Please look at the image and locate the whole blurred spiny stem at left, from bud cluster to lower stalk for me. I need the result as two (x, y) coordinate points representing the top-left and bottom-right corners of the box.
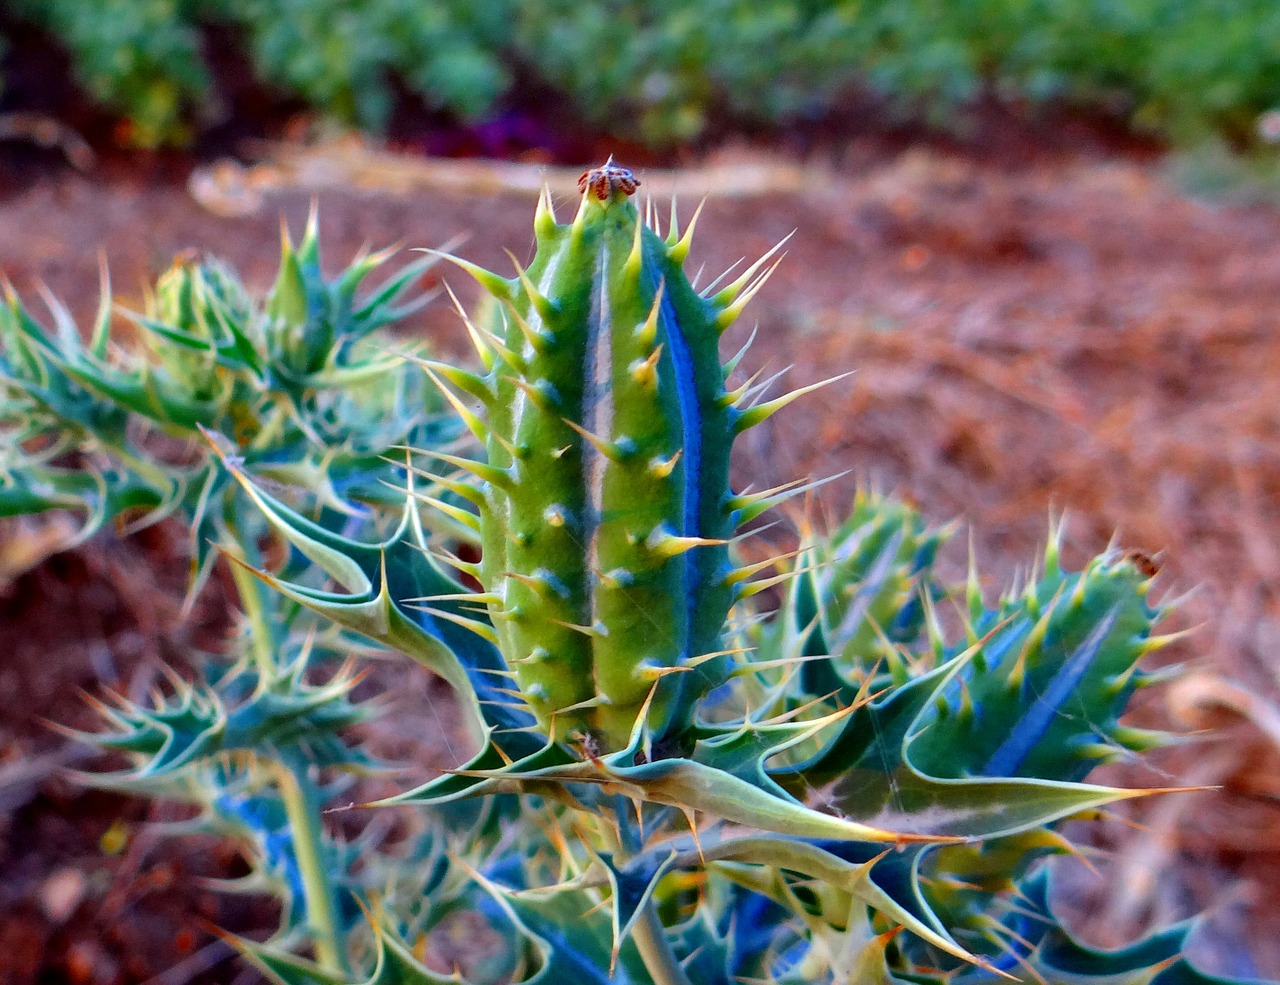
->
(0, 210), (471, 967)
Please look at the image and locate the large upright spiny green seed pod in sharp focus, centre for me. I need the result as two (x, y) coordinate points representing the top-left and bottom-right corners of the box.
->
(428, 159), (804, 750)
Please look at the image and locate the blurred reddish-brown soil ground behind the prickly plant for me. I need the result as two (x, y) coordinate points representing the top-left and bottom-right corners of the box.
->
(0, 126), (1280, 985)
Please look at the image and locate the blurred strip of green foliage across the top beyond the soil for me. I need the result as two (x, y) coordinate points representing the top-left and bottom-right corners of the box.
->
(0, 0), (1280, 146)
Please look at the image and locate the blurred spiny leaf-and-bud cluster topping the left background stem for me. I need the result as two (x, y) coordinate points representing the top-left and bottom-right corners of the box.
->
(0, 211), (458, 587)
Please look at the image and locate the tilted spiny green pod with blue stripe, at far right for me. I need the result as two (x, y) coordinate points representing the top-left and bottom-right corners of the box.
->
(911, 544), (1179, 782)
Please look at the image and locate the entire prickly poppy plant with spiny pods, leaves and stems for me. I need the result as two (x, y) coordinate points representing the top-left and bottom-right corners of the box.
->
(0, 160), (1269, 985)
